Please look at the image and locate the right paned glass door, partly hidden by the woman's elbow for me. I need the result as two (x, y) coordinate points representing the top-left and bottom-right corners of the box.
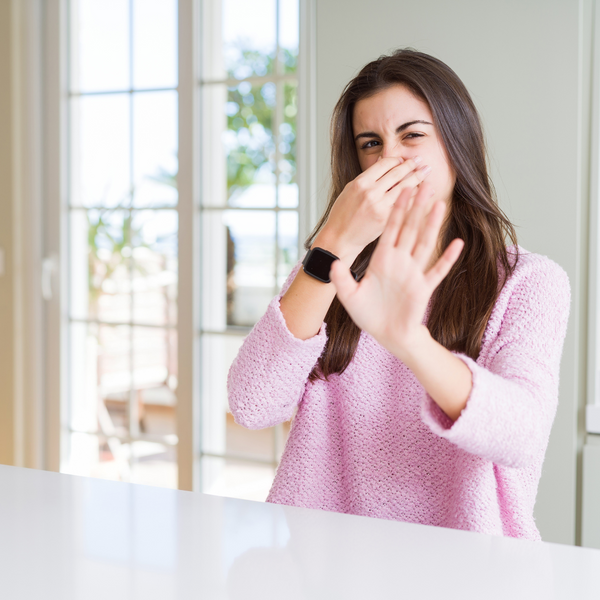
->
(199, 0), (299, 499)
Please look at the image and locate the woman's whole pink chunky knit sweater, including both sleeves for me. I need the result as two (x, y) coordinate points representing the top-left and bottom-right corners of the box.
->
(228, 248), (570, 540)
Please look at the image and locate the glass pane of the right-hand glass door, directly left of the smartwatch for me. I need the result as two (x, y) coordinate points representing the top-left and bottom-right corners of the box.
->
(224, 210), (276, 326)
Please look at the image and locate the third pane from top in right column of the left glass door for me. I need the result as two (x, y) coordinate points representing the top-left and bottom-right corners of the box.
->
(131, 210), (178, 325)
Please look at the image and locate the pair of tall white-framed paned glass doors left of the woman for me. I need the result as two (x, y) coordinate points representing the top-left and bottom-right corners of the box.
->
(55, 0), (307, 500)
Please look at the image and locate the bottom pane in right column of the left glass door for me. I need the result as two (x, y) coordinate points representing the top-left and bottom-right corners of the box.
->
(131, 441), (177, 489)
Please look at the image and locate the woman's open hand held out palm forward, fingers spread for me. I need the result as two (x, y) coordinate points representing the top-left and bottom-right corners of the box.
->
(331, 183), (464, 360)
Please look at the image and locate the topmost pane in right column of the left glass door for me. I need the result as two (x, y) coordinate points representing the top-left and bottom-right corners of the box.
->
(133, 0), (177, 89)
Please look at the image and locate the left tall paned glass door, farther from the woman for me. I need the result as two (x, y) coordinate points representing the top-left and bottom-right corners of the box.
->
(63, 0), (178, 487)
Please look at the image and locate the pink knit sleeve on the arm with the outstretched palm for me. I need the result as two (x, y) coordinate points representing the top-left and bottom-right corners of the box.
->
(422, 256), (570, 468)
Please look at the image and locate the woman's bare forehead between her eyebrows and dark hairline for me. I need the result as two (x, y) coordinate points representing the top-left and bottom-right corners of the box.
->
(352, 85), (433, 135)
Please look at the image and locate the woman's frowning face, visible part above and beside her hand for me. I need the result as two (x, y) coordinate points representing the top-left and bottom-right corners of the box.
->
(352, 85), (456, 203)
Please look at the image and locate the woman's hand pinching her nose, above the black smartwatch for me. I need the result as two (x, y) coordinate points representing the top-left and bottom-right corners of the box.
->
(313, 156), (431, 264)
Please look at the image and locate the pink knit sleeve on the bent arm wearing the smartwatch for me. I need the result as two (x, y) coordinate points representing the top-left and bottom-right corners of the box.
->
(227, 263), (327, 429)
